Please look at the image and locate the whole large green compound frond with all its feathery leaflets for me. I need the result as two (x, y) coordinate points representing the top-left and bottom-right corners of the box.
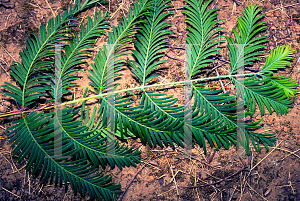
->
(3, 0), (298, 200)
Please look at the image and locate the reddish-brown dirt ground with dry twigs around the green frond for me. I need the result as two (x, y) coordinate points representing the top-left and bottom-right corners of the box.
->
(0, 0), (300, 201)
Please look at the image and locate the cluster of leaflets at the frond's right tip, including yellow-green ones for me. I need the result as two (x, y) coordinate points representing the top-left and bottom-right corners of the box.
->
(227, 4), (296, 118)
